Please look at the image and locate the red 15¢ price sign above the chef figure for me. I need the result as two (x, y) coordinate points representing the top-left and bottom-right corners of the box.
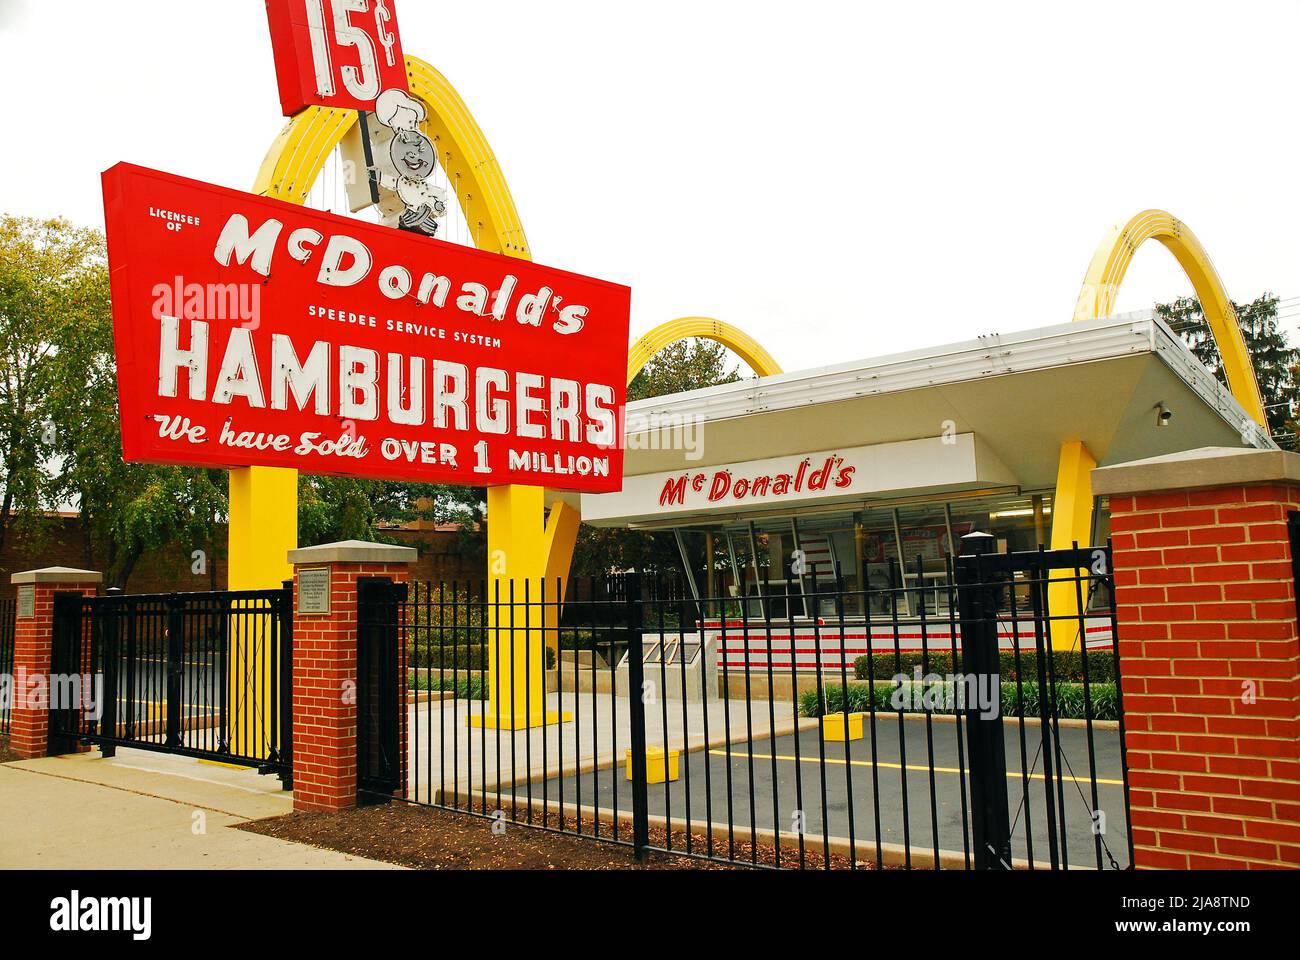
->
(267, 0), (408, 117)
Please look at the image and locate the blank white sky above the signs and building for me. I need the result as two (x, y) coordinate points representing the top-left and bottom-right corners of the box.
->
(0, 0), (1300, 369)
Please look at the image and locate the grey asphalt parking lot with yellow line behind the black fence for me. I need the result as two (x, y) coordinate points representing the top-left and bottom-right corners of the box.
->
(534, 714), (1128, 869)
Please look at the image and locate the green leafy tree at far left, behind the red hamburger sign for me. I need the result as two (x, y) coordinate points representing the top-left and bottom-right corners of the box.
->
(0, 216), (226, 587)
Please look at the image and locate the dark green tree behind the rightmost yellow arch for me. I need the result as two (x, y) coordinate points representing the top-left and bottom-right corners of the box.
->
(1156, 293), (1300, 450)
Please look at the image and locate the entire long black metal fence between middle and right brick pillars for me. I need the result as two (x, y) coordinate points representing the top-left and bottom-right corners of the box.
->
(359, 548), (1132, 869)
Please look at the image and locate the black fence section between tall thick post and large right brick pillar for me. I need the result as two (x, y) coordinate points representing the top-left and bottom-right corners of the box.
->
(956, 539), (1132, 870)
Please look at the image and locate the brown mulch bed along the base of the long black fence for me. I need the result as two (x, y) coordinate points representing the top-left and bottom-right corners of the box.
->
(238, 803), (870, 870)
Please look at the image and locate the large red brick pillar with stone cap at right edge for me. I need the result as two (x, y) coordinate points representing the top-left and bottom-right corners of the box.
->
(1093, 447), (1300, 869)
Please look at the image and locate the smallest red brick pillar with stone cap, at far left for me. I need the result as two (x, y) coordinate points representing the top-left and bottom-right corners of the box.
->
(9, 567), (104, 760)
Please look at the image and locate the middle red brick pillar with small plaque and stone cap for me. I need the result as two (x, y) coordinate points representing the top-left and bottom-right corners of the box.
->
(289, 540), (419, 812)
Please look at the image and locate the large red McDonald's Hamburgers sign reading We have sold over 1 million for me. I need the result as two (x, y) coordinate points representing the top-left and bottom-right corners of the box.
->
(104, 164), (631, 493)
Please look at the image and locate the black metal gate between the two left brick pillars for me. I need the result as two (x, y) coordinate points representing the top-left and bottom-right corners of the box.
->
(49, 585), (293, 783)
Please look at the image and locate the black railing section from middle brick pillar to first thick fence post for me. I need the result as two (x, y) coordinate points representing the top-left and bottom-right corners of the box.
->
(392, 578), (642, 844)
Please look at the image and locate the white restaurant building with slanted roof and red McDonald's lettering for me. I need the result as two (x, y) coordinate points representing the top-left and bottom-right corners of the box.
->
(581, 312), (1274, 670)
